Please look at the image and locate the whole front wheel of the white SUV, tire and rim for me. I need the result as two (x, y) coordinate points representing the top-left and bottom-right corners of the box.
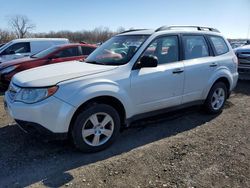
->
(71, 104), (121, 153)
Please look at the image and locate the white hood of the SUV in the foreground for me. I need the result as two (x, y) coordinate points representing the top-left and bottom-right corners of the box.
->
(12, 61), (117, 87)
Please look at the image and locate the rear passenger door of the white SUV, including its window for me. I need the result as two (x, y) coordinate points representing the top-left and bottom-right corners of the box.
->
(182, 34), (218, 103)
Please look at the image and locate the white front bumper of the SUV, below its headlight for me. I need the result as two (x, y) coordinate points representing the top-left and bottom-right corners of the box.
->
(4, 92), (76, 133)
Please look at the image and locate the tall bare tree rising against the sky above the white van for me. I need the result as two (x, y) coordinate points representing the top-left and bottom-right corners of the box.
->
(9, 15), (36, 38)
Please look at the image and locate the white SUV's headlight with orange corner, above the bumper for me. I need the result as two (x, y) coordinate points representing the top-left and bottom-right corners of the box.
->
(15, 86), (58, 104)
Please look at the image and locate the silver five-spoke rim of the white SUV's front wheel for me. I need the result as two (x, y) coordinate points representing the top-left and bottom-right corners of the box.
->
(82, 112), (114, 146)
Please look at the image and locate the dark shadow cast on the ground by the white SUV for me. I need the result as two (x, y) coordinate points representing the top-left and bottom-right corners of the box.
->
(0, 107), (219, 187)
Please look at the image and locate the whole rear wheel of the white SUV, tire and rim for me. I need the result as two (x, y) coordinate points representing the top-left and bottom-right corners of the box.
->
(204, 82), (228, 114)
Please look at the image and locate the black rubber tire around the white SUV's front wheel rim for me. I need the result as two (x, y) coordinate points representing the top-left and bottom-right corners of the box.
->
(71, 104), (121, 153)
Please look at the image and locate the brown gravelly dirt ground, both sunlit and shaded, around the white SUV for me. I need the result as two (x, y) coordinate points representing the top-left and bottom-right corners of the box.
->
(0, 81), (250, 188)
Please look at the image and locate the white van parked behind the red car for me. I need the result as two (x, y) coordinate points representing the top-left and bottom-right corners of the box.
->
(0, 38), (69, 63)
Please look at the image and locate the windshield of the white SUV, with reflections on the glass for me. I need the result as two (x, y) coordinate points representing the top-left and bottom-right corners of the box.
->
(86, 35), (148, 65)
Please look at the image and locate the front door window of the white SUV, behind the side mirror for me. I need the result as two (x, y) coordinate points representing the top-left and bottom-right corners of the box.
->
(142, 36), (179, 64)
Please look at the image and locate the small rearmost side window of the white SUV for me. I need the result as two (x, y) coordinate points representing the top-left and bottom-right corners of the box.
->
(209, 36), (229, 55)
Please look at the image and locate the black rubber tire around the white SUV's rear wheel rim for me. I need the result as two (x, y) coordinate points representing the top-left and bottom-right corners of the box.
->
(204, 82), (228, 114)
